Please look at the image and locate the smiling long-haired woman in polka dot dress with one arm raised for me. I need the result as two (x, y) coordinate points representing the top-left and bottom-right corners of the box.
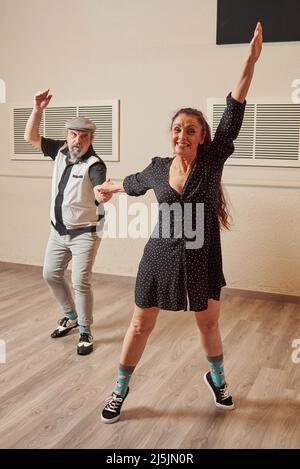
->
(99, 23), (262, 423)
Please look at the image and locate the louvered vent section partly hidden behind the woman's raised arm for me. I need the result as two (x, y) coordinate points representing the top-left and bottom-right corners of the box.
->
(212, 104), (255, 159)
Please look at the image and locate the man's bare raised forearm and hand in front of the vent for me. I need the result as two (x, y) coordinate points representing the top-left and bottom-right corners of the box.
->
(24, 90), (52, 151)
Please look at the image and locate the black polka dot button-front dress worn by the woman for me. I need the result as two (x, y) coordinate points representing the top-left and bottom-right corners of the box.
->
(124, 94), (246, 311)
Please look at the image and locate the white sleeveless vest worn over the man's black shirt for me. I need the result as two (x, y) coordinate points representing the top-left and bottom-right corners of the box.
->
(50, 144), (101, 230)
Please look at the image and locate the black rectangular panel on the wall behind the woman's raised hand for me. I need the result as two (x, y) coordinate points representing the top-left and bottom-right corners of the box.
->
(217, 0), (300, 44)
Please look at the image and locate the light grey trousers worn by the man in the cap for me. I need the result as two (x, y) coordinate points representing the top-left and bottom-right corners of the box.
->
(43, 227), (101, 326)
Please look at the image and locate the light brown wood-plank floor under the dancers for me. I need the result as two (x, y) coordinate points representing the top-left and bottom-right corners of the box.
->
(0, 264), (300, 449)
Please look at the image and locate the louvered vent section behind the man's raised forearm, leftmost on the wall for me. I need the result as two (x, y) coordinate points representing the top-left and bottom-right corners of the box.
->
(13, 108), (44, 155)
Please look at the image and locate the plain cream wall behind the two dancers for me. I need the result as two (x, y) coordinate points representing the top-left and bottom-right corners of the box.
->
(0, 0), (300, 295)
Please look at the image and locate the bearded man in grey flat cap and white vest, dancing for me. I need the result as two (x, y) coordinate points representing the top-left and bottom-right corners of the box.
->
(24, 90), (106, 355)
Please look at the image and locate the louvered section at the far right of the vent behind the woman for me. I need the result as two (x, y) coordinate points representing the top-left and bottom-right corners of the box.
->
(255, 104), (300, 161)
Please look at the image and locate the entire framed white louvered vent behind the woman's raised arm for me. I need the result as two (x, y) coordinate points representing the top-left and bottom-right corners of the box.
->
(208, 98), (300, 167)
